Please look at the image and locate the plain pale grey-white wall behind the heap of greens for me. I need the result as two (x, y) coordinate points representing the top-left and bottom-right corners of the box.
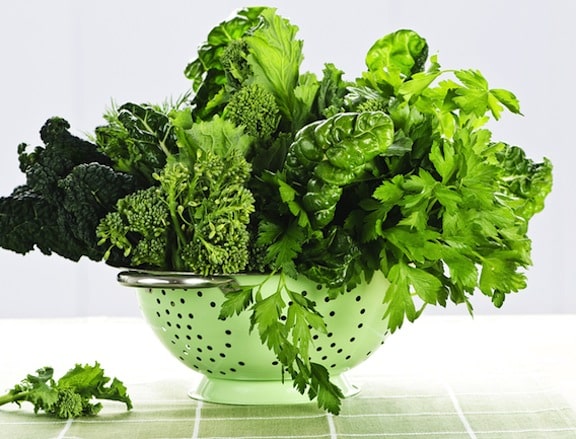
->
(0, 0), (576, 317)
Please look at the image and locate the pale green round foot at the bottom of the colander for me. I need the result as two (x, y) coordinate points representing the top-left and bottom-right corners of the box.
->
(188, 375), (360, 405)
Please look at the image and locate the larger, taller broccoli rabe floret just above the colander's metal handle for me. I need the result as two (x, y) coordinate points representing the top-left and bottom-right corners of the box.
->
(158, 149), (254, 275)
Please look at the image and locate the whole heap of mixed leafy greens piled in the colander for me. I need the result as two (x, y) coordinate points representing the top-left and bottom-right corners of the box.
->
(0, 7), (552, 413)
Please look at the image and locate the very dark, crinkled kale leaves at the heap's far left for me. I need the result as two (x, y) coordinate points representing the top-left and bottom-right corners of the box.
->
(0, 118), (135, 262)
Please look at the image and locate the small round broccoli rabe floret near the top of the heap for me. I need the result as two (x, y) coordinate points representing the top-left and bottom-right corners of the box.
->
(224, 84), (280, 140)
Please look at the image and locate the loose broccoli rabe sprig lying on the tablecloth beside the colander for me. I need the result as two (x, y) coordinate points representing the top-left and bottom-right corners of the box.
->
(0, 362), (132, 419)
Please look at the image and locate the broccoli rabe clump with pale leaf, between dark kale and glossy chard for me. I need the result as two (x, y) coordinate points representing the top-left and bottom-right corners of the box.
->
(97, 119), (254, 275)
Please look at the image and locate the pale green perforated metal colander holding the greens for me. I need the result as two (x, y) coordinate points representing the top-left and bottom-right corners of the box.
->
(118, 271), (388, 404)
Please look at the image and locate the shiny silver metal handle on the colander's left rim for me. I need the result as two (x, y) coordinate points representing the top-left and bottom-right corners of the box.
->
(117, 270), (240, 293)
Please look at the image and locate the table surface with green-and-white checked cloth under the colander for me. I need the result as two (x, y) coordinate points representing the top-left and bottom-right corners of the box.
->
(0, 315), (576, 439)
